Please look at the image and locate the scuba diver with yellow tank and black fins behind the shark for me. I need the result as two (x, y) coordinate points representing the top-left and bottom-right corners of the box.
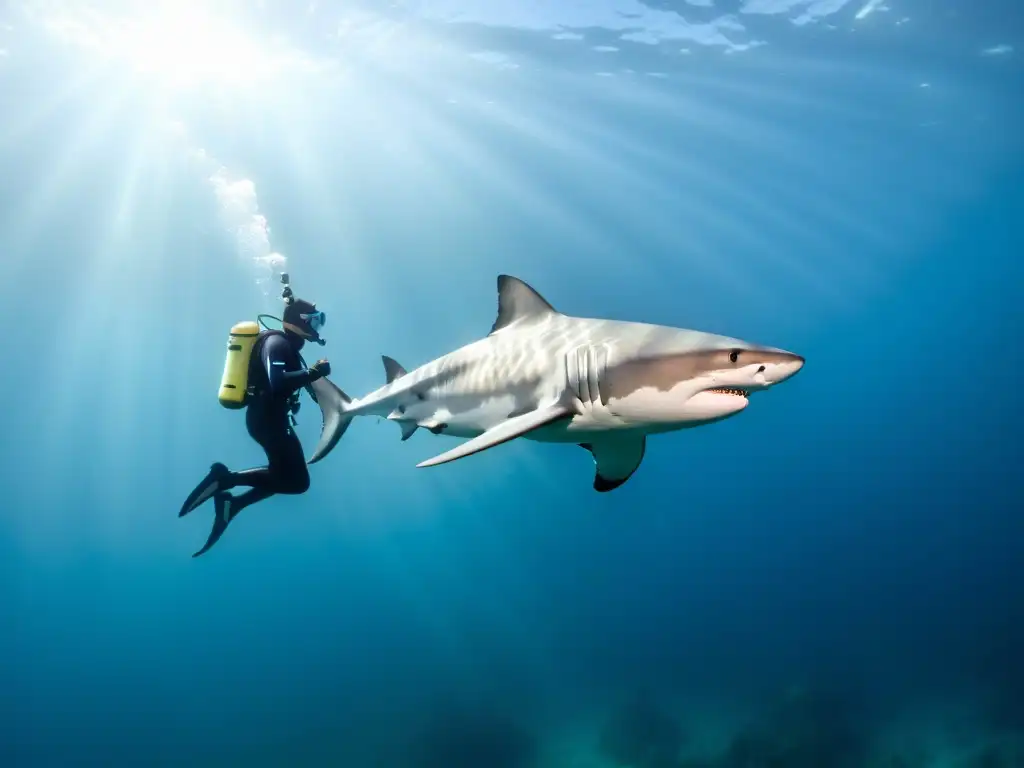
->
(178, 273), (331, 557)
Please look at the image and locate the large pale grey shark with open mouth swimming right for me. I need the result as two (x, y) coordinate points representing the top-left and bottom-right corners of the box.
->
(308, 274), (804, 493)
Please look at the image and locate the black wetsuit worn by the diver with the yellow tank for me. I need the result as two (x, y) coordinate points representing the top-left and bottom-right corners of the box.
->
(225, 333), (316, 514)
